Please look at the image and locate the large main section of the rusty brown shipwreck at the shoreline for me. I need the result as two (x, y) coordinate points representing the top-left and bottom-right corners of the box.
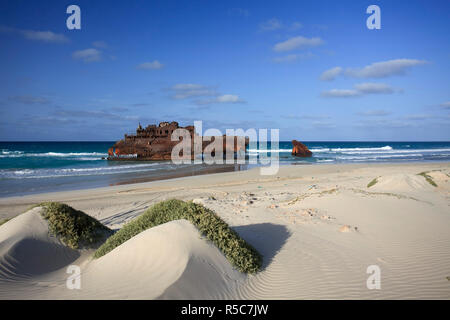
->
(107, 121), (249, 161)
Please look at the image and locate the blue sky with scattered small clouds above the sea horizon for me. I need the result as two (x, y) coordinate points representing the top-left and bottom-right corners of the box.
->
(0, 0), (450, 141)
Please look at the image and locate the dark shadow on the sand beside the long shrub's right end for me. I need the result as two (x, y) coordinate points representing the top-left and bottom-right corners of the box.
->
(232, 223), (291, 270)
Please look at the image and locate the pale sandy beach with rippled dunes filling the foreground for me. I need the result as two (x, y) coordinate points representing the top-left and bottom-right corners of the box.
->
(0, 163), (450, 299)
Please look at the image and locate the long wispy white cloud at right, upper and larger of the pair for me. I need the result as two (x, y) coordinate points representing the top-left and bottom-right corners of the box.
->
(346, 59), (427, 78)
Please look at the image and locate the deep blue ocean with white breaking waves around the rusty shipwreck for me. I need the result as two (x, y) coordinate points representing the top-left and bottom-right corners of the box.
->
(0, 141), (450, 197)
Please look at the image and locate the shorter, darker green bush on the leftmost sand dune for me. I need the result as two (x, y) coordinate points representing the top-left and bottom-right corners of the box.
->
(36, 202), (112, 249)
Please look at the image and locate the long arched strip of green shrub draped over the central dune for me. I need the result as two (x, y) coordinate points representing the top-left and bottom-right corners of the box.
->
(94, 199), (262, 273)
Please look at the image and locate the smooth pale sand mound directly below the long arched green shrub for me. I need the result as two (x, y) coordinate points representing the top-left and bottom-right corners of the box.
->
(82, 220), (242, 299)
